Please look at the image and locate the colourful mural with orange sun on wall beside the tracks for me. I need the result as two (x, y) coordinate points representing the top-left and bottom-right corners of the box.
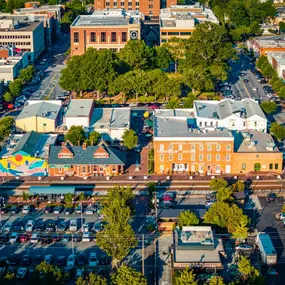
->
(0, 151), (47, 176)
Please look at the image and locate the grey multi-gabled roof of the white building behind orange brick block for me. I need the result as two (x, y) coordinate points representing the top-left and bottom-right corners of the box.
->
(194, 99), (266, 120)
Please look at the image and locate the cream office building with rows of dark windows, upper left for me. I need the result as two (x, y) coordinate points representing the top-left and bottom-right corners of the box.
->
(0, 14), (45, 62)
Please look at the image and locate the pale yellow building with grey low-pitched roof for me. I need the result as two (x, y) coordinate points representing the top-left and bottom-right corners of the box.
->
(16, 100), (61, 133)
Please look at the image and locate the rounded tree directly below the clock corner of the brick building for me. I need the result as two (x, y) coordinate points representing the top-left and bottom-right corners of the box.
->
(118, 40), (154, 70)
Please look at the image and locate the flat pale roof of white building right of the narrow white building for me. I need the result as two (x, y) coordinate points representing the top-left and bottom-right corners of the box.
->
(90, 108), (131, 130)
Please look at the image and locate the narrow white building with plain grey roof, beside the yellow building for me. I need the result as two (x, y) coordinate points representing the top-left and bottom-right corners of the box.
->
(63, 99), (94, 130)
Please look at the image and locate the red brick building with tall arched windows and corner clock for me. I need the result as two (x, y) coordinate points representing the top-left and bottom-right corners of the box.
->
(70, 9), (143, 55)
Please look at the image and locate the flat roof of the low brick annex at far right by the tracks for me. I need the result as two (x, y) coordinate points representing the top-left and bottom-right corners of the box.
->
(233, 130), (280, 153)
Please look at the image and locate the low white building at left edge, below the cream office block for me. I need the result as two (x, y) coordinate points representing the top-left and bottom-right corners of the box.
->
(0, 53), (29, 83)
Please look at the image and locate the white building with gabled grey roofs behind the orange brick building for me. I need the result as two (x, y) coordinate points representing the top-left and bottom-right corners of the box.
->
(194, 99), (267, 132)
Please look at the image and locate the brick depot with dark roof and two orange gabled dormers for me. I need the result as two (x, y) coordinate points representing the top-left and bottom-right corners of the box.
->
(48, 141), (126, 177)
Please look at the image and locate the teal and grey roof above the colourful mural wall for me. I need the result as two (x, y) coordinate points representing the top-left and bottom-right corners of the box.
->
(0, 131), (57, 158)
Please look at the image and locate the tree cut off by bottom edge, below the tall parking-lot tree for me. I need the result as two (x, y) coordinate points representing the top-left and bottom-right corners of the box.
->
(111, 264), (147, 285)
